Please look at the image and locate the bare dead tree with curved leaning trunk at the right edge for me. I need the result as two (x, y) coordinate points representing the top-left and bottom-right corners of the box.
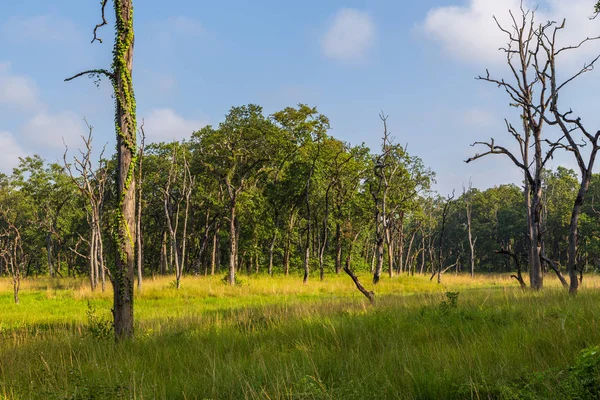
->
(535, 20), (600, 294)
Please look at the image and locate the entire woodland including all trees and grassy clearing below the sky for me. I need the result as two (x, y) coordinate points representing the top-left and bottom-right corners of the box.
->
(0, 0), (600, 399)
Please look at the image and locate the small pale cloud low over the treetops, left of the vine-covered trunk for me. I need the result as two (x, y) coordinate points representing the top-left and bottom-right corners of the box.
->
(21, 111), (86, 150)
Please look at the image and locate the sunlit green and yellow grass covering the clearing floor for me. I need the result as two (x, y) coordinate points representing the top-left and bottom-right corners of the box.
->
(0, 274), (600, 400)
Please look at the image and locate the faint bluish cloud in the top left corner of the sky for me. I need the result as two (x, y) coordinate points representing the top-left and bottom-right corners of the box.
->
(0, 15), (78, 42)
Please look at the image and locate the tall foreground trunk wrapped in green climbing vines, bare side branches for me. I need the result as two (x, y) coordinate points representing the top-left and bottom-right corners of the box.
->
(65, 0), (137, 341)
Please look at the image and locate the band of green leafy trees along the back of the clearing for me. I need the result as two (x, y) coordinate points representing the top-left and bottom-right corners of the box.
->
(0, 101), (600, 298)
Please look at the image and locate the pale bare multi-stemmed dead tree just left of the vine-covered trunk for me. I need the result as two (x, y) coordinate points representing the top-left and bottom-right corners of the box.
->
(63, 121), (107, 292)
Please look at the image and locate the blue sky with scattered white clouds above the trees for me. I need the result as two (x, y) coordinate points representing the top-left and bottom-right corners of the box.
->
(0, 0), (600, 194)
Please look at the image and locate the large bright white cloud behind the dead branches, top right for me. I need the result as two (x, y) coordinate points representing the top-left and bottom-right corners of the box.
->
(420, 0), (599, 67)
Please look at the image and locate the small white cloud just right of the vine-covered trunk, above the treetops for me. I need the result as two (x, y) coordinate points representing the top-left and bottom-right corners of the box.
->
(139, 108), (206, 143)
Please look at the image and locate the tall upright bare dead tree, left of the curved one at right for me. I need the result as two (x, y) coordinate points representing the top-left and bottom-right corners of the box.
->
(466, 7), (564, 290)
